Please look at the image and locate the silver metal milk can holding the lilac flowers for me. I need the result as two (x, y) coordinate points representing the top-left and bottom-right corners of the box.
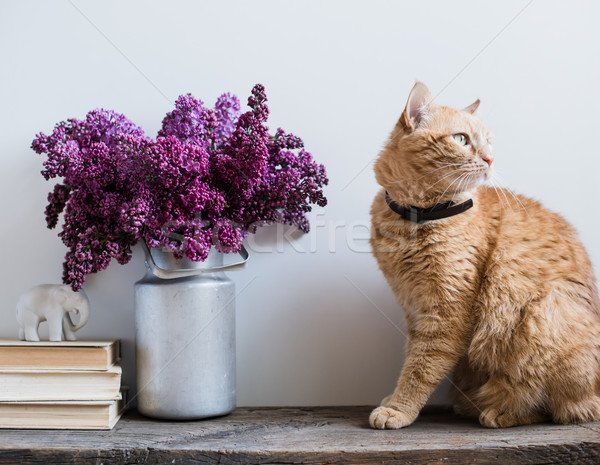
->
(135, 247), (248, 420)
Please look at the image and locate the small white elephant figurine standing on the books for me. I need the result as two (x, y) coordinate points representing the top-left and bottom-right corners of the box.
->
(17, 284), (90, 341)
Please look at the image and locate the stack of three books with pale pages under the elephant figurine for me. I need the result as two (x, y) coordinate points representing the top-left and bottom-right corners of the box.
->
(0, 340), (125, 429)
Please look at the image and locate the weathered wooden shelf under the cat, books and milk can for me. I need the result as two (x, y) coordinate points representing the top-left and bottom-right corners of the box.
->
(0, 407), (600, 465)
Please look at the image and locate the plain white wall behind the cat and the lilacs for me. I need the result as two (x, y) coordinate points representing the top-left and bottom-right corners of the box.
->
(0, 0), (600, 405)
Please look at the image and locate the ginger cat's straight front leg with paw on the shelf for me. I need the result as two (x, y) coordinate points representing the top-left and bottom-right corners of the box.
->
(369, 317), (467, 429)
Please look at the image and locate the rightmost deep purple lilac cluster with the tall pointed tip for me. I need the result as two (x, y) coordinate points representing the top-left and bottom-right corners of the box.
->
(213, 85), (328, 233)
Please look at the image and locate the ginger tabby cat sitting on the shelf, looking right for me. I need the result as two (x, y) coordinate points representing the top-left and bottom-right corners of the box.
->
(369, 82), (600, 429)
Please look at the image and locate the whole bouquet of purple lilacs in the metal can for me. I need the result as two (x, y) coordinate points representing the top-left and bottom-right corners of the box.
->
(32, 84), (328, 290)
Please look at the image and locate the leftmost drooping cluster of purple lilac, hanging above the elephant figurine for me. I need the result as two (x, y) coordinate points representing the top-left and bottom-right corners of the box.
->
(32, 109), (144, 290)
